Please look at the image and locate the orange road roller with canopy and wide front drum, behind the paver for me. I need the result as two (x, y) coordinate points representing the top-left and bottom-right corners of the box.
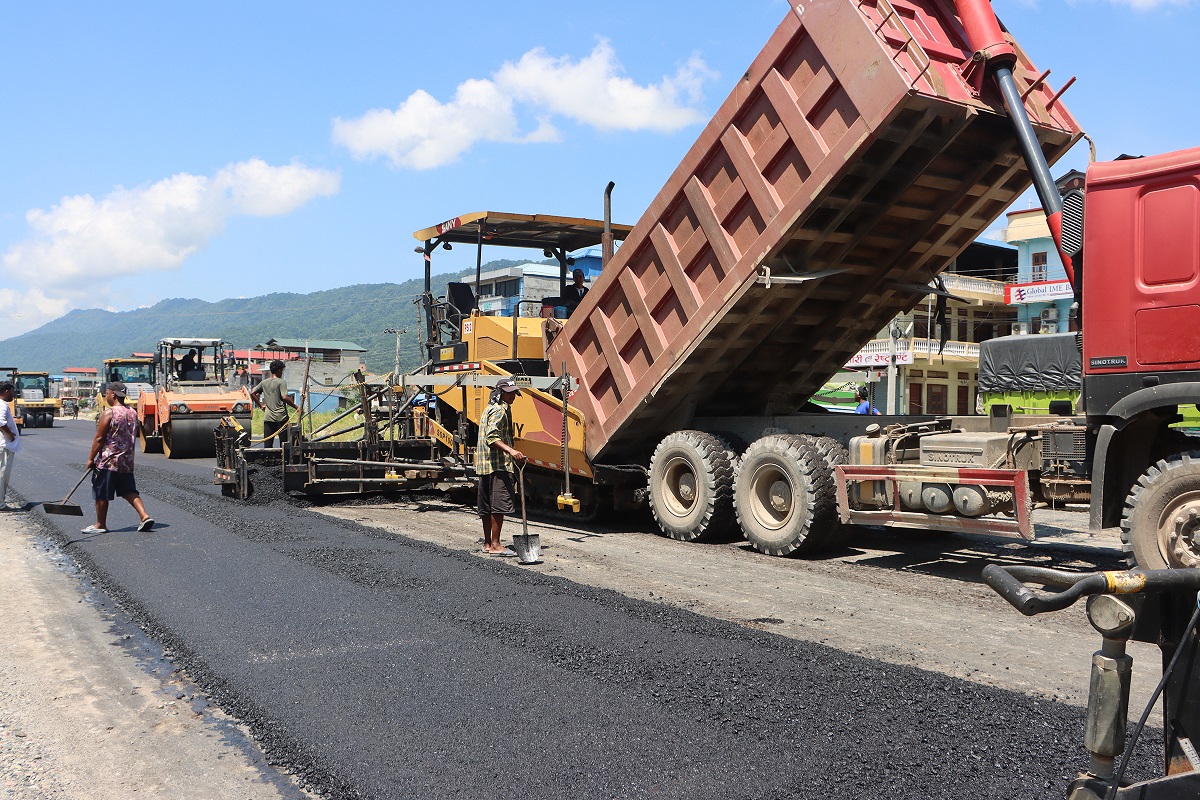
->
(138, 337), (253, 458)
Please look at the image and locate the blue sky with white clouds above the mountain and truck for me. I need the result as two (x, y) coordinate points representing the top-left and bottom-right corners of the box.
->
(0, 0), (1200, 338)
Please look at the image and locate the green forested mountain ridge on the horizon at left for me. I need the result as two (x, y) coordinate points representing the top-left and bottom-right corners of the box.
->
(0, 260), (501, 373)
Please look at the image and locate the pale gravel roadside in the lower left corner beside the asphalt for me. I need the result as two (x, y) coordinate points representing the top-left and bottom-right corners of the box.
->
(0, 513), (304, 800)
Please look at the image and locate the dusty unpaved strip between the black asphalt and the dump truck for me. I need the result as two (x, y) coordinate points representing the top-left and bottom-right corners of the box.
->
(313, 498), (1160, 724)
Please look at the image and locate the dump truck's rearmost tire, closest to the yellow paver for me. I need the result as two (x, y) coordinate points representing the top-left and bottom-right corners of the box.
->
(649, 431), (734, 542)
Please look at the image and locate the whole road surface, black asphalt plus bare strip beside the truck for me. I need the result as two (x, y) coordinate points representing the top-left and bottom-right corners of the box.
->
(0, 421), (1159, 798)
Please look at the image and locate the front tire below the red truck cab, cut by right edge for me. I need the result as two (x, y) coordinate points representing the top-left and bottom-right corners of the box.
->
(1121, 450), (1200, 570)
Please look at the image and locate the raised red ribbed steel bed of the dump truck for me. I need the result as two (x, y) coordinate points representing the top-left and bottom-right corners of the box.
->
(550, 0), (1080, 462)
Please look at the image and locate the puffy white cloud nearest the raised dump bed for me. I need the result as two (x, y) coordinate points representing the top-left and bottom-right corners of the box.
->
(332, 41), (714, 169)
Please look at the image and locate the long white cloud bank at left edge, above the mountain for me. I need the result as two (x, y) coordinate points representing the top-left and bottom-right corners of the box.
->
(0, 158), (341, 336)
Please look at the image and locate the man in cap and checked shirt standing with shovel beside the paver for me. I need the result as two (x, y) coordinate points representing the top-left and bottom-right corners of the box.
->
(475, 378), (526, 557)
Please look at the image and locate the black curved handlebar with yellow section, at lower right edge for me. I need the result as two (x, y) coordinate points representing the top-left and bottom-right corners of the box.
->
(983, 564), (1200, 616)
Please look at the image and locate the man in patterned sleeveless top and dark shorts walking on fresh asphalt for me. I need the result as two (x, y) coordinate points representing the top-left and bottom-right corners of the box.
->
(83, 381), (154, 534)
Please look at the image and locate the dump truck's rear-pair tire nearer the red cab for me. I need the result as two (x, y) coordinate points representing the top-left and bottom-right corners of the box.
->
(733, 434), (838, 555)
